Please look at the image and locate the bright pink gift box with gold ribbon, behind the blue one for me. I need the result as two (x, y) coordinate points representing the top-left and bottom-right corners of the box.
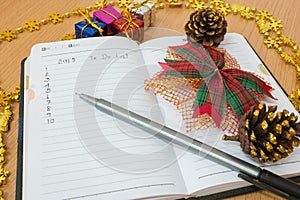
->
(93, 6), (122, 35)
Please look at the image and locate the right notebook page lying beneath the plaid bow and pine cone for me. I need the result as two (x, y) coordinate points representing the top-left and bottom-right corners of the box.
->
(142, 33), (300, 195)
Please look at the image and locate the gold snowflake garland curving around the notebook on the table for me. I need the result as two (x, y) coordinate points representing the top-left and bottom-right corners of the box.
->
(0, 0), (300, 199)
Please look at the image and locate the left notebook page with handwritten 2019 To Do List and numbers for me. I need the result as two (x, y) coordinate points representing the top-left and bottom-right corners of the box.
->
(24, 38), (186, 199)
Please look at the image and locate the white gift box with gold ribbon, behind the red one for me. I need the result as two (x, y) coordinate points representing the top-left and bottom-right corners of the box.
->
(129, 0), (155, 29)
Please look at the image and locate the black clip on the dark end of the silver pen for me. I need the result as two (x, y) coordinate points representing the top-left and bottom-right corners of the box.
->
(238, 173), (297, 200)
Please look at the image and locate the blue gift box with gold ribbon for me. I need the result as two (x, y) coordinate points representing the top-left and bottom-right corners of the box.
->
(75, 17), (107, 39)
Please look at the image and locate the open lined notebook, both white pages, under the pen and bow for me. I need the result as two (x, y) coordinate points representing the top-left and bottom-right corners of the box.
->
(19, 33), (300, 200)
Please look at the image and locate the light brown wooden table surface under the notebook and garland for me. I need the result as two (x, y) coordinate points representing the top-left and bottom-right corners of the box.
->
(0, 0), (300, 200)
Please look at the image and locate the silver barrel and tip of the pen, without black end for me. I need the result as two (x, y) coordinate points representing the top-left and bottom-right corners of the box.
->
(78, 94), (261, 179)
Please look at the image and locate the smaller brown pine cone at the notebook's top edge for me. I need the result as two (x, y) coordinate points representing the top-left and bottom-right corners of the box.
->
(184, 9), (227, 47)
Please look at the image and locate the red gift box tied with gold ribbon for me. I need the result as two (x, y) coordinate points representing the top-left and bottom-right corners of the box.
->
(113, 14), (144, 42)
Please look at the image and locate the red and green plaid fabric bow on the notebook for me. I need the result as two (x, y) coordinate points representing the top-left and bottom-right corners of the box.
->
(158, 42), (275, 127)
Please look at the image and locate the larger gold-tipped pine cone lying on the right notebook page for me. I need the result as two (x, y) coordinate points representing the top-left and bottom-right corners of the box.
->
(223, 104), (300, 163)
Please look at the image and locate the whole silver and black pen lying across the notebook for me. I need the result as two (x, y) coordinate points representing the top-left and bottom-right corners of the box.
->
(76, 93), (300, 199)
